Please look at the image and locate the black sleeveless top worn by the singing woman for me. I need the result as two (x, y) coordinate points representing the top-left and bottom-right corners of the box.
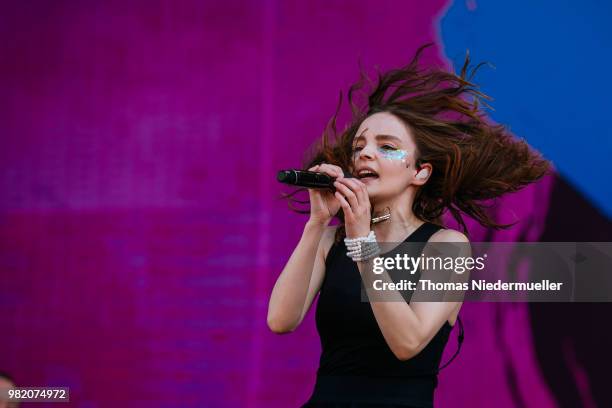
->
(303, 222), (453, 408)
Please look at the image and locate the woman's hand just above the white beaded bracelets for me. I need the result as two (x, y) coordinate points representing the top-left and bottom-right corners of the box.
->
(334, 178), (372, 238)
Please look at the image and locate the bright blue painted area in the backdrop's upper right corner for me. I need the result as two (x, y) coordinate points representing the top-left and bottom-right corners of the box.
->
(440, 0), (612, 217)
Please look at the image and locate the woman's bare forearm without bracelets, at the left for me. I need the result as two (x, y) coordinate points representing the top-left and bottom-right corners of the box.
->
(268, 221), (337, 334)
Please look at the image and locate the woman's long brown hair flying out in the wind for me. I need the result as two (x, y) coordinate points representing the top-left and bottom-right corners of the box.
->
(284, 44), (550, 238)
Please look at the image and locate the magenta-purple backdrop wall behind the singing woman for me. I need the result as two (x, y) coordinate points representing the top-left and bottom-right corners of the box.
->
(0, 0), (580, 407)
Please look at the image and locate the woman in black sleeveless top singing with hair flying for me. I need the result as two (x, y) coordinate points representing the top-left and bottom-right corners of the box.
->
(268, 46), (549, 407)
